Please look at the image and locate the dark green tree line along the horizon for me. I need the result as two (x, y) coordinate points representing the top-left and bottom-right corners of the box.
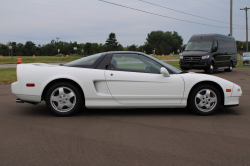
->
(0, 31), (250, 56)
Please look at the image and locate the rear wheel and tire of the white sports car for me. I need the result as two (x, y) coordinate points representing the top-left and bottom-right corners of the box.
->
(45, 82), (82, 116)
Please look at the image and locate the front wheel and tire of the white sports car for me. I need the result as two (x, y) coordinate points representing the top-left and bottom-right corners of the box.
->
(188, 84), (221, 115)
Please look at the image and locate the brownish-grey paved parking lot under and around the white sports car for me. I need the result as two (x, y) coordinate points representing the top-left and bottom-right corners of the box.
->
(0, 69), (250, 166)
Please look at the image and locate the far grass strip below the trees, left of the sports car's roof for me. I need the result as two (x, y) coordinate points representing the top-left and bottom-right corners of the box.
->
(0, 56), (82, 64)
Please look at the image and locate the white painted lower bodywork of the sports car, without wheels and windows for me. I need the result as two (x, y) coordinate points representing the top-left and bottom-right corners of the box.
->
(11, 63), (242, 108)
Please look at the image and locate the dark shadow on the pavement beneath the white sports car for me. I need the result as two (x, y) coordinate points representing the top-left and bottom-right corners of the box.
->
(16, 103), (240, 117)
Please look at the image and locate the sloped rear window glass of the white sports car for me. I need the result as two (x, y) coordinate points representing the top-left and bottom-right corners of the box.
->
(65, 54), (102, 66)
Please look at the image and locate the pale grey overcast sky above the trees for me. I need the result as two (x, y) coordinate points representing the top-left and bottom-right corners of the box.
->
(0, 0), (250, 47)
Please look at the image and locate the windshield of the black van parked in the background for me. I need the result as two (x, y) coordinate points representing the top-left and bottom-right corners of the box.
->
(185, 41), (212, 51)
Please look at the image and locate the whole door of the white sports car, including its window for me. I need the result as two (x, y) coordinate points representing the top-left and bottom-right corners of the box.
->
(105, 54), (184, 104)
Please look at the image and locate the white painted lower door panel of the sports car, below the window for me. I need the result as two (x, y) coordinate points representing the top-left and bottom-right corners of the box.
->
(105, 70), (184, 105)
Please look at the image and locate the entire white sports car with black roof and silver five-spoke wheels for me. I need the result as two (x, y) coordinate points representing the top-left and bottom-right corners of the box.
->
(11, 51), (242, 116)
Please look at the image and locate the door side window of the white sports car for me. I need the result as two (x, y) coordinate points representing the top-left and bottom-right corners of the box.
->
(110, 54), (161, 74)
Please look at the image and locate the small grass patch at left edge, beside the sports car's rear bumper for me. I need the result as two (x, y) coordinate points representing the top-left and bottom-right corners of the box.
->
(0, 68), (17, 85)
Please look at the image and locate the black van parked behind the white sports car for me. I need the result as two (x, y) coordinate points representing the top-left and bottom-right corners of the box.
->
(180, 34), (237, 74)
